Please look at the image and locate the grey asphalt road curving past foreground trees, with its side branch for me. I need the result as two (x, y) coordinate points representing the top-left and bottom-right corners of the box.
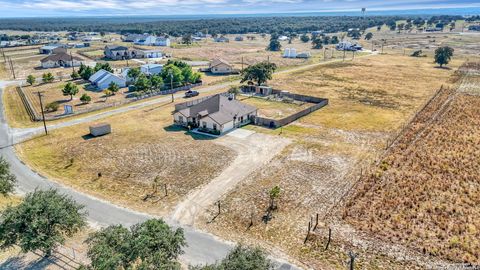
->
(0, 82), (298, 270)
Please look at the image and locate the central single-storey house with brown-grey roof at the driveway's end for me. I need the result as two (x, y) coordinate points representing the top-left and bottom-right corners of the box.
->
(173, 94), (257, 135)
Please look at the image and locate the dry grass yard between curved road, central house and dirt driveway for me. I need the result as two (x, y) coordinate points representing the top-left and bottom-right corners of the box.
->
(17, 95), (234, 215)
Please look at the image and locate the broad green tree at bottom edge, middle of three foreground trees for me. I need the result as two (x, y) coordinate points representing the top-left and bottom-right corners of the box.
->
(86, 219), (186, 269)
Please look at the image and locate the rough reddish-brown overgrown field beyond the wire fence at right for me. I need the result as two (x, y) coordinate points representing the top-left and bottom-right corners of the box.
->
(345, 66), (480, 264)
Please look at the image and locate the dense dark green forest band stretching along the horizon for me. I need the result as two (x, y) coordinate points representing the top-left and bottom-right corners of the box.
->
(0, 16), (462, 36)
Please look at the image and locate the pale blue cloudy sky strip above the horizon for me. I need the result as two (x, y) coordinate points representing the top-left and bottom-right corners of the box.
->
(0, 0), (480, 18)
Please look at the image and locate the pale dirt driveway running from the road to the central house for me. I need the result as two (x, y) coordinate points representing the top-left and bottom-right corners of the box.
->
(171, 129), (291, 226)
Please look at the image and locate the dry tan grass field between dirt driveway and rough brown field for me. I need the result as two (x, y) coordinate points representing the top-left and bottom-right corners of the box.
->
(197, 55), (461, 269)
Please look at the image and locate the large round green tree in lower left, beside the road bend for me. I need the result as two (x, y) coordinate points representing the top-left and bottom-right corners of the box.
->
(0, 189), (86, 256)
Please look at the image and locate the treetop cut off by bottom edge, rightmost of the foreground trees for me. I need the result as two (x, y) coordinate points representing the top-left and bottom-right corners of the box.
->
(191, 245), (274, 270)
